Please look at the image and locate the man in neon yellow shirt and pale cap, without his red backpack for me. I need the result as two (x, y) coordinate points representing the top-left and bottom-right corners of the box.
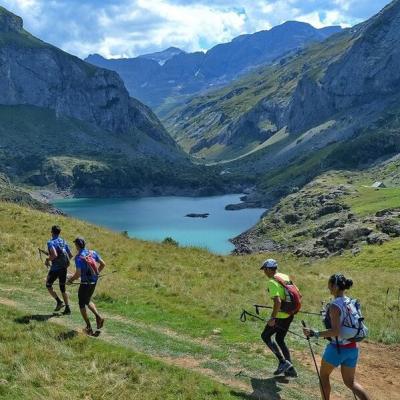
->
(261, 258), (297, 377)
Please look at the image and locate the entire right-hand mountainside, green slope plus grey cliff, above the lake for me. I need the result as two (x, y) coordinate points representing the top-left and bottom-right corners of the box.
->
(166, 0), (400, 173)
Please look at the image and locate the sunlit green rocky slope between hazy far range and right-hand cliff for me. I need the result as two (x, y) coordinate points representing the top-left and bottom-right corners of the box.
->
(163, 31), (354, 162)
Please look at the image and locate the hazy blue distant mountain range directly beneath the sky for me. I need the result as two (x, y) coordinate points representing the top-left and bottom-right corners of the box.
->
(86, 21), (341, 109)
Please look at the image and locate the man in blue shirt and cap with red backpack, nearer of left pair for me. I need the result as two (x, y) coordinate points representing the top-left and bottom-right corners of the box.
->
(68, 237), (106, 335)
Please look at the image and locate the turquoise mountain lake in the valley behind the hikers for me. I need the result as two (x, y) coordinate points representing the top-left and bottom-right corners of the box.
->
(54, 195), (265, 254)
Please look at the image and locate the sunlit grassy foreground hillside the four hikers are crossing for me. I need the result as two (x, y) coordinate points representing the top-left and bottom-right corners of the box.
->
(0, 203), (400, 400)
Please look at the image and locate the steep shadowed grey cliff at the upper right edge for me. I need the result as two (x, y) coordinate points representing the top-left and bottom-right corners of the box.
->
(288, 1), (400, 132)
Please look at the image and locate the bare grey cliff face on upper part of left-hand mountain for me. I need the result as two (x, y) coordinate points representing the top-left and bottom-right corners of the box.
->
(0, 6), (177, 150)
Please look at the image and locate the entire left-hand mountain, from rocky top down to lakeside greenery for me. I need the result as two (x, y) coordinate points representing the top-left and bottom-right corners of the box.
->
(0, 8), (223, 194)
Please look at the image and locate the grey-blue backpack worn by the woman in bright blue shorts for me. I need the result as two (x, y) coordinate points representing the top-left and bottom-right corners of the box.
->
(322, 297), (368, 342)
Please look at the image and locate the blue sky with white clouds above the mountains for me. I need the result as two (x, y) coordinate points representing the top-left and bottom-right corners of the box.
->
(1, 0), (390, 57)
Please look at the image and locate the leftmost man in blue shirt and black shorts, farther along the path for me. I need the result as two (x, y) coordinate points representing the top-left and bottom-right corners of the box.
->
(45, 225), (72, 315)
